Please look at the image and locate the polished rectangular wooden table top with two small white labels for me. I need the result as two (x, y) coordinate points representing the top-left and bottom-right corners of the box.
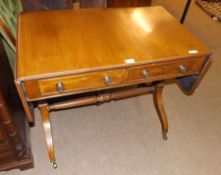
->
(16, 6), (209, 80)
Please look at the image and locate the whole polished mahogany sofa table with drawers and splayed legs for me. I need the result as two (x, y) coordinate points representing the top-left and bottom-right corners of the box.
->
(15, 7), (211, 167)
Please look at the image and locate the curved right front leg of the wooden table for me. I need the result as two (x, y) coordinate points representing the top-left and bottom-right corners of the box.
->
(154, 83), (168, 140)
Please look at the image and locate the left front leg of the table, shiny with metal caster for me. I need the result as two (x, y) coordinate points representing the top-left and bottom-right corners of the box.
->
(38, 103), (57, 168)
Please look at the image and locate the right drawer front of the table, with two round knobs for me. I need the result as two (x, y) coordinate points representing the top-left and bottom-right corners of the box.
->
(127, 57), (205, 82)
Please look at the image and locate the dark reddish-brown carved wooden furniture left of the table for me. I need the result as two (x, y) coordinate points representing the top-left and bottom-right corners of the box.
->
(0, 39), (33, 170)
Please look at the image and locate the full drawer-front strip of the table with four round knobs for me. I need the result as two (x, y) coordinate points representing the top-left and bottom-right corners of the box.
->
(25, 57), (205, 100)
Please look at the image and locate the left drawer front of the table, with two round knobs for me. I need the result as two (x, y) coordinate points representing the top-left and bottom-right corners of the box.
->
(25, 69), (126, 99)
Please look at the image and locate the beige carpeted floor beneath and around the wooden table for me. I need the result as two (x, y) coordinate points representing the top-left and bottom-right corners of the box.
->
(0, 0), (221, 175)
